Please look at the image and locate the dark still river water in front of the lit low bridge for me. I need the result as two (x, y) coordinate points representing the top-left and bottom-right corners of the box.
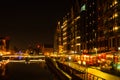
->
(5, 62), (58, 80)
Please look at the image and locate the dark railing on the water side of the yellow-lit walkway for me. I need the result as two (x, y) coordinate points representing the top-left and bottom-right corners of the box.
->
(57, 61), (105, 80)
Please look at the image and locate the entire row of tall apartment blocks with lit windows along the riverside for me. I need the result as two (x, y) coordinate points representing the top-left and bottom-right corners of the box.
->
(55, 0), (120, 54)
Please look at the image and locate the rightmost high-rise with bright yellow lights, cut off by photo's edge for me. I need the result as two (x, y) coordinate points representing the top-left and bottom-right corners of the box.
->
(97, 0), (120, 51)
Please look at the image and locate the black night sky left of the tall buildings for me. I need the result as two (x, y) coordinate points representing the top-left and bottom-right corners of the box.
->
(0, 0), (71, 48)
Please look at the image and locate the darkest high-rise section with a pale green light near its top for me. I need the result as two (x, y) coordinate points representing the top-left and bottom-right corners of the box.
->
(79, 0), (98, 53)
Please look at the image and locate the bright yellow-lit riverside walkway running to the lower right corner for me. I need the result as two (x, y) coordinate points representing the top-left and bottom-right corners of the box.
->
(59, 61), (120, 80)
